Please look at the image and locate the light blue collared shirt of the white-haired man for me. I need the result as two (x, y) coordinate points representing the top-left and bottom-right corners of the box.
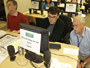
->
(70, 26), (90, 57)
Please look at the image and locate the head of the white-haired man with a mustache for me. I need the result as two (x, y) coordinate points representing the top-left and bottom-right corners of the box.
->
(73, 16), (85, 36)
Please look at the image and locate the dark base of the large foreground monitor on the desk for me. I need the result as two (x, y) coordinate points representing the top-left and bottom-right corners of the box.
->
(25, 50), (44, 63)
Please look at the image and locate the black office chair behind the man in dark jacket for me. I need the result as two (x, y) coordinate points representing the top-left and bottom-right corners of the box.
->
(59, 15), (72, 44)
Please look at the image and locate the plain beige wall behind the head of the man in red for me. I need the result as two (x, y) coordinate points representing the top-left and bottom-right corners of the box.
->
(4, 0), (31, 17)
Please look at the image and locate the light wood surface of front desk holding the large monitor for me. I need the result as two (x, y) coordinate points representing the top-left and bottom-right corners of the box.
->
(0, 32), (78, 68)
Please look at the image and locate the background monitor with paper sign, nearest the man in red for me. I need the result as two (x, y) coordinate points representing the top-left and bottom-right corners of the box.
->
(31, 0), (43, 13)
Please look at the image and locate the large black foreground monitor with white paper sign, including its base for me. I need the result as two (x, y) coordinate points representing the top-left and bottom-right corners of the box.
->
(20, 23), (49, 63)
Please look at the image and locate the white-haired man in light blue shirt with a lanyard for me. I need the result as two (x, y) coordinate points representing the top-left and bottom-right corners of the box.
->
(70, 16), (90, 68)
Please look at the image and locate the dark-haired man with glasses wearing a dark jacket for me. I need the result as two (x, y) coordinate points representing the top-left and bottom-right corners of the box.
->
(41, 6), (65, 42)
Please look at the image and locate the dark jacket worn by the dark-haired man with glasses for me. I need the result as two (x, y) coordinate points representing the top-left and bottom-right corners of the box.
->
(40, 18), (65, 42)
